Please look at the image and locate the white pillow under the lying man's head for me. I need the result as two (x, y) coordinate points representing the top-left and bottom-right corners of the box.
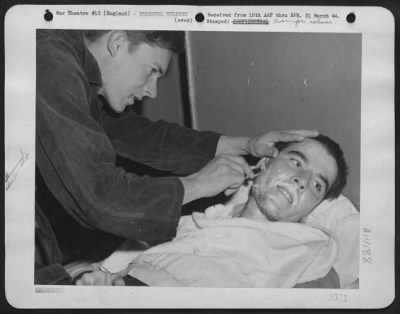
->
(227, 184), (360, 289)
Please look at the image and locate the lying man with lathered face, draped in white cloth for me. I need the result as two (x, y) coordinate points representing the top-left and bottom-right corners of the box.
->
(76, 135), (347, 288)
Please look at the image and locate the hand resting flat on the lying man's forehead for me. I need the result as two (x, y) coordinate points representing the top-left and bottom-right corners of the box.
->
(248, 130), (318, 157)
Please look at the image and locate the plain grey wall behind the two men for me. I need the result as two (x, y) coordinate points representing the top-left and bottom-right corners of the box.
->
(144, 32), (361, 207)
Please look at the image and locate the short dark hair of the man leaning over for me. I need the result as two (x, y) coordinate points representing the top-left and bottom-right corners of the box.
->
(83, 30), (185, 53)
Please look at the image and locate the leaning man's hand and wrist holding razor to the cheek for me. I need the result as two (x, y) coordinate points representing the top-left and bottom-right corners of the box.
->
(181, 154), (254, 204)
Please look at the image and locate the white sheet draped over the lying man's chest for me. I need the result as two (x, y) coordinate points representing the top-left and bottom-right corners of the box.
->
(111, 205), (336, 287)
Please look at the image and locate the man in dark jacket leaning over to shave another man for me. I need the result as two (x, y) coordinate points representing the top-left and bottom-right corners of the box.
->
(35, 30), (318, 284)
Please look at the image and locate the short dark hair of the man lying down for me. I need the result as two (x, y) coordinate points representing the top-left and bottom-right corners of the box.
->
(275, 134), (348, 200)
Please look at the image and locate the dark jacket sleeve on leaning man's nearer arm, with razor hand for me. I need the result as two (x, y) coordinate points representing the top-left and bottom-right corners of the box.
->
(36, 31), (183, 240)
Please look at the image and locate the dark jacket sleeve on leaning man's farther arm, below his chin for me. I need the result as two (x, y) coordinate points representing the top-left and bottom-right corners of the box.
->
(99, 107), (219, 175)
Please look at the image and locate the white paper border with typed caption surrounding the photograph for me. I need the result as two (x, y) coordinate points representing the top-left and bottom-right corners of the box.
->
(5, 5), (395, 308)
